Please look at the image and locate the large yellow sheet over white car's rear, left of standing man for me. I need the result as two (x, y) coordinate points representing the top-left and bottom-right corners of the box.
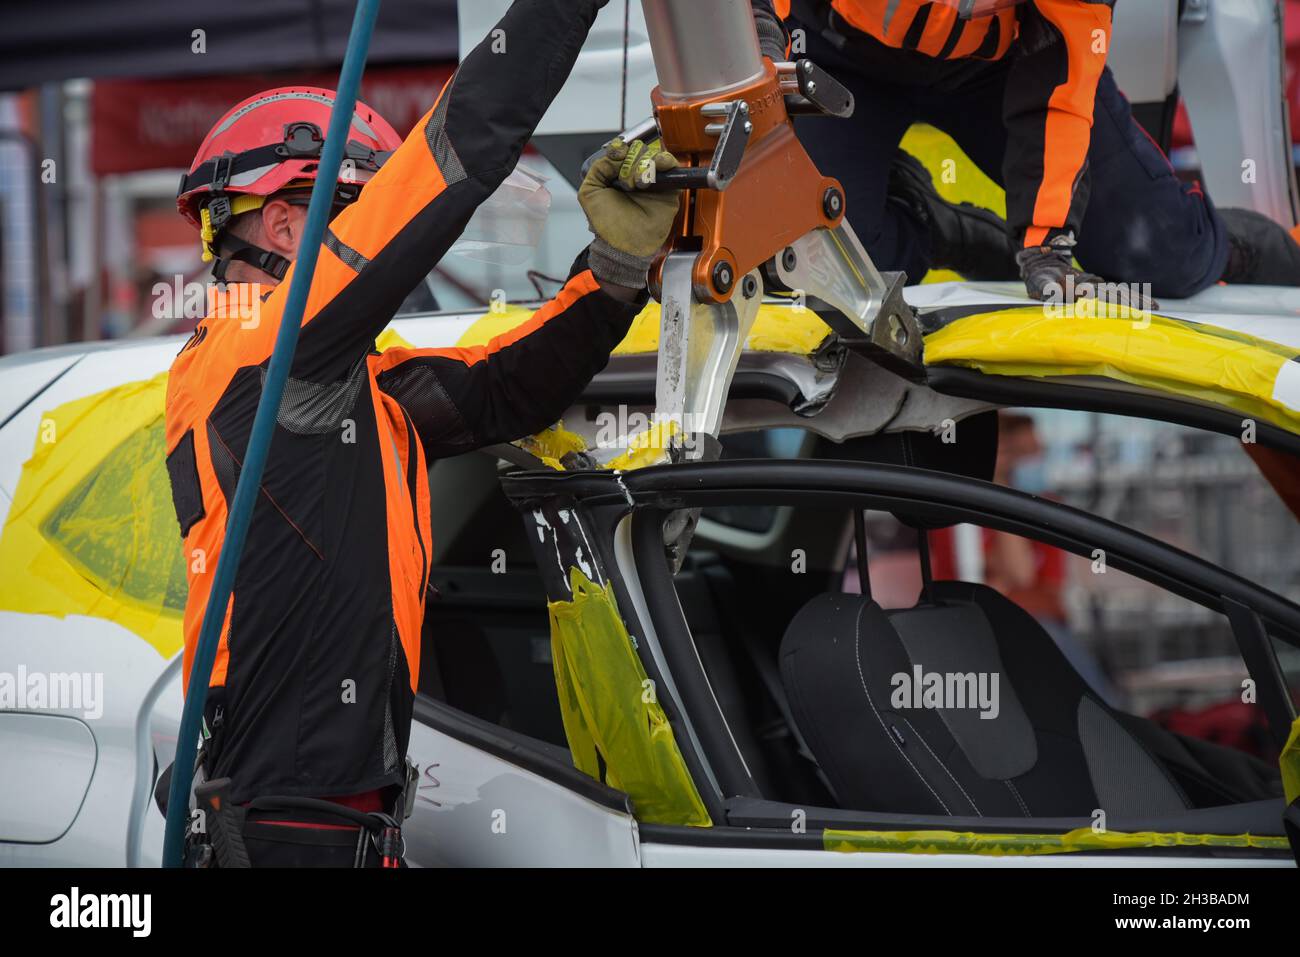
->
(0, 373), (186, 657)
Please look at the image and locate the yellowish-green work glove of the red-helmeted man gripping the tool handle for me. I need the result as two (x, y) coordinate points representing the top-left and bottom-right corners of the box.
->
(577, 139), (680, 289)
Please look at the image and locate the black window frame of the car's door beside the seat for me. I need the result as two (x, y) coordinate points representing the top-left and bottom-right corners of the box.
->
(503, 460), (1300, 863)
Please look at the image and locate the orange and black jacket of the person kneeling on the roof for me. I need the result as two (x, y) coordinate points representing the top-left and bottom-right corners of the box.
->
(754, 0), (1114, 246)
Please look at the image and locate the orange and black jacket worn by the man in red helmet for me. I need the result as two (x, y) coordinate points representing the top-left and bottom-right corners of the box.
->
(166, 0), (638, 801)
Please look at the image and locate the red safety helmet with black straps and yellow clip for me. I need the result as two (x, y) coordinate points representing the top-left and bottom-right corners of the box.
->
(176, 86), (402, 280)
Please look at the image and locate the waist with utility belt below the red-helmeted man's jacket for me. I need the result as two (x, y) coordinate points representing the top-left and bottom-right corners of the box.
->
(185, 759), (419, 869)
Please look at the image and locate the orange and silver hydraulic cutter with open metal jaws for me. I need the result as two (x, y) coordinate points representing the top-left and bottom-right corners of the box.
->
(624, 0), (922, 460)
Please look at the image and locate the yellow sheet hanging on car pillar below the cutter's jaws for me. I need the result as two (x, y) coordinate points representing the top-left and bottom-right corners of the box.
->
(547, 568), (712, 827)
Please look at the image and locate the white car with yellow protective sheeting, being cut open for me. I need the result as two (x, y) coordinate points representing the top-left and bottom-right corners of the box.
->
(0, 283), (1300, 866)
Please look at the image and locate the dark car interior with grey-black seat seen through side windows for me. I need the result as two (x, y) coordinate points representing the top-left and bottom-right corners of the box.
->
(420, 413), (1282, 833)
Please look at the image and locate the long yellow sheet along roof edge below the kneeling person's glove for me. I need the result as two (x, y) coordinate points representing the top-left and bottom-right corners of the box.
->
(926, 300), (1300, 433)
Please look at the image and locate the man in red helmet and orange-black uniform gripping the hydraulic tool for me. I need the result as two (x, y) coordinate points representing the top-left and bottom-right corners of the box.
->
(166, 0), (679, 866)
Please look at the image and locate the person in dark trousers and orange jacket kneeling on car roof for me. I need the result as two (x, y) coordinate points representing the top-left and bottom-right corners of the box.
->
(751, 0), (1300, 306)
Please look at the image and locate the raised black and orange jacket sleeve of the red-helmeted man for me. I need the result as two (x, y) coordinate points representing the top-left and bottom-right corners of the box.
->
(277, 0), (607, 382)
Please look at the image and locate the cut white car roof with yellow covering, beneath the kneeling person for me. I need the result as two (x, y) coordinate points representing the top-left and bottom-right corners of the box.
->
(0, 282), (1300, 451)
